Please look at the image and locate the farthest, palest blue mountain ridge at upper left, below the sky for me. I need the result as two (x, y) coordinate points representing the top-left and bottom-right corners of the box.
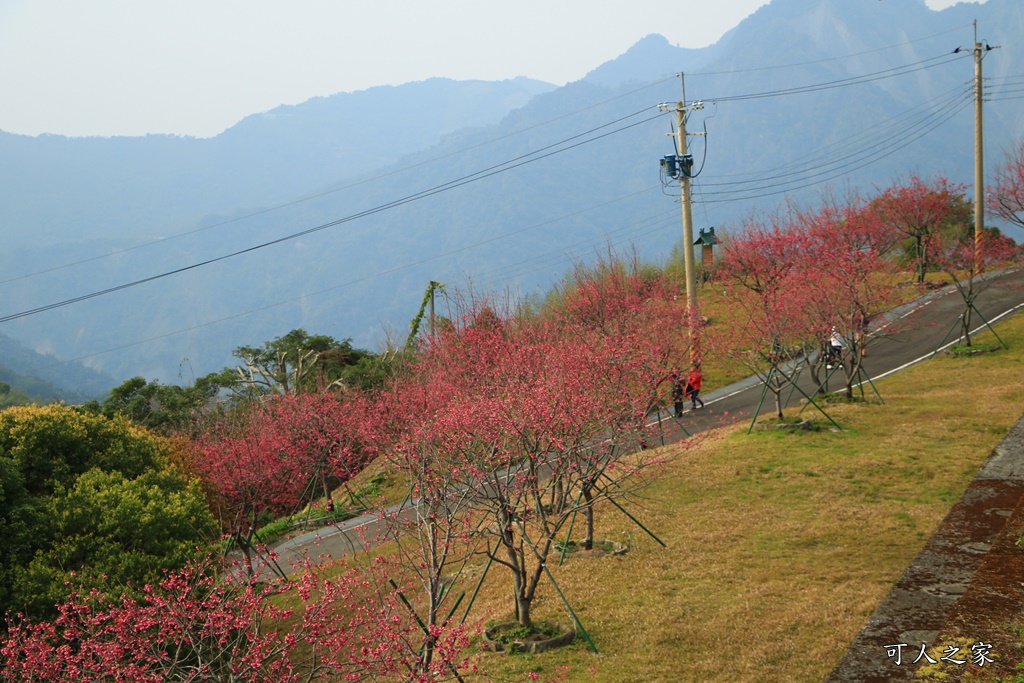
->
(0, 78), (554, 247)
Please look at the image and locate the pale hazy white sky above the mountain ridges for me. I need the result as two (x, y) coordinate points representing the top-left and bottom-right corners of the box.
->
(0, 0), (974, 136)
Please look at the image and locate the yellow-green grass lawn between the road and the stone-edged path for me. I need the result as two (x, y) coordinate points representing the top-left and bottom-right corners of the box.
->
(458, 316), (1024, 683)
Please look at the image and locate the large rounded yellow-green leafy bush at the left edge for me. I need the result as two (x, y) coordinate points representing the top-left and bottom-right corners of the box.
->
(0, 404), (216, 615)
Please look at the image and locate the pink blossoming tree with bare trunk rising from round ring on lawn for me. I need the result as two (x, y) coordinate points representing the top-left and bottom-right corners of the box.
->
(387, 274), (682, 625)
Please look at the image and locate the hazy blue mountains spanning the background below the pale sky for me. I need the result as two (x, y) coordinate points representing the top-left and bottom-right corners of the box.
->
(0, 0), (1024, 397)
